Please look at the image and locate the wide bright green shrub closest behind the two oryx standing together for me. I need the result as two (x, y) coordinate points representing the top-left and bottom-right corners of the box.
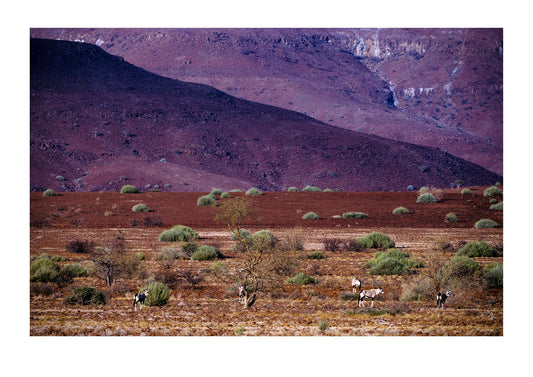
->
(365, 249), (424, 275)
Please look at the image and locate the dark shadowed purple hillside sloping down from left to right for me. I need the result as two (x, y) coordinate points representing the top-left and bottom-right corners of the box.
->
(30, 39), (502, 191)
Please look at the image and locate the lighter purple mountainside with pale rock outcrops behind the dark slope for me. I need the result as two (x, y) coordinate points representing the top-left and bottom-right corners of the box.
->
(31, 29), (503, 174)
